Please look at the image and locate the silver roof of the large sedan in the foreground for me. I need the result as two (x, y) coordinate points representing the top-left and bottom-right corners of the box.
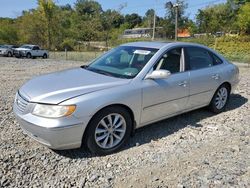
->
(121, 41), (207, 49)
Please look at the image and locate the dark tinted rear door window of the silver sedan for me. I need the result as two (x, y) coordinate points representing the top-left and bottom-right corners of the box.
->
(186, 47), (214, 70)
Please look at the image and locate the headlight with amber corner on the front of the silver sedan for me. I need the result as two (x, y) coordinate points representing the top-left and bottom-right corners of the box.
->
(32, 104), (76, 118)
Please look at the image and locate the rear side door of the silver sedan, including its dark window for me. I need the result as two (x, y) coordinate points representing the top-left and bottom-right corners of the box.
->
(185, 47), (222, 108)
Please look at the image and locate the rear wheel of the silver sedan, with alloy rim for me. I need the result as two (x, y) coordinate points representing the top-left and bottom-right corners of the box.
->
(209, 84), (230, 113)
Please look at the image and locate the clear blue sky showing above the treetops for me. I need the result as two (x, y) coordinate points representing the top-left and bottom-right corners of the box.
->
(0, 0), (226, 19)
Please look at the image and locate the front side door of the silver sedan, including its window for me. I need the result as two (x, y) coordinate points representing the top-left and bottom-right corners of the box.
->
(141, 48), (189, 124)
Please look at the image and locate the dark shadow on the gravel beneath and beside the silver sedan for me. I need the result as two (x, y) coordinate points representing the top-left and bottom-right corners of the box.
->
(54, 94), (248, 159)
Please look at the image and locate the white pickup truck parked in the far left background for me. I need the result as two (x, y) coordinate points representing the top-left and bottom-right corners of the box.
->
(14, 44), (49, 59)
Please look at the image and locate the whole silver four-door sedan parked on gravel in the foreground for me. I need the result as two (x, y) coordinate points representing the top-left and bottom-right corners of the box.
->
(14, 42), (239, 155)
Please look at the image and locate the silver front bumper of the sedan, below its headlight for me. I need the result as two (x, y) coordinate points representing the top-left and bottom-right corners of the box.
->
(13, 94), (88, 150)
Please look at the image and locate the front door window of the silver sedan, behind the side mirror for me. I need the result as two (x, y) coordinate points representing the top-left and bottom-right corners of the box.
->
(153, 48), (182, 74)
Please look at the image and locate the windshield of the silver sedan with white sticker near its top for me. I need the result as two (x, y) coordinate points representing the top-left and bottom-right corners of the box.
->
(84, 46), (158, 79)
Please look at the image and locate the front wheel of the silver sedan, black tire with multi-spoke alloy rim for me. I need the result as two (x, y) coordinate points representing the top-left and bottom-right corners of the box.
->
(83, 106), (132, 155)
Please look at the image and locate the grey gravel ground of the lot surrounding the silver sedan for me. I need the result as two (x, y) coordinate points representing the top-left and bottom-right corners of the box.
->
(0, 57), (250, 188)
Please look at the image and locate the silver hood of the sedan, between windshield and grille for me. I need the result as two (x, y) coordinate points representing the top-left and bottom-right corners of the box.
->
(19, 68), (130, 104)
